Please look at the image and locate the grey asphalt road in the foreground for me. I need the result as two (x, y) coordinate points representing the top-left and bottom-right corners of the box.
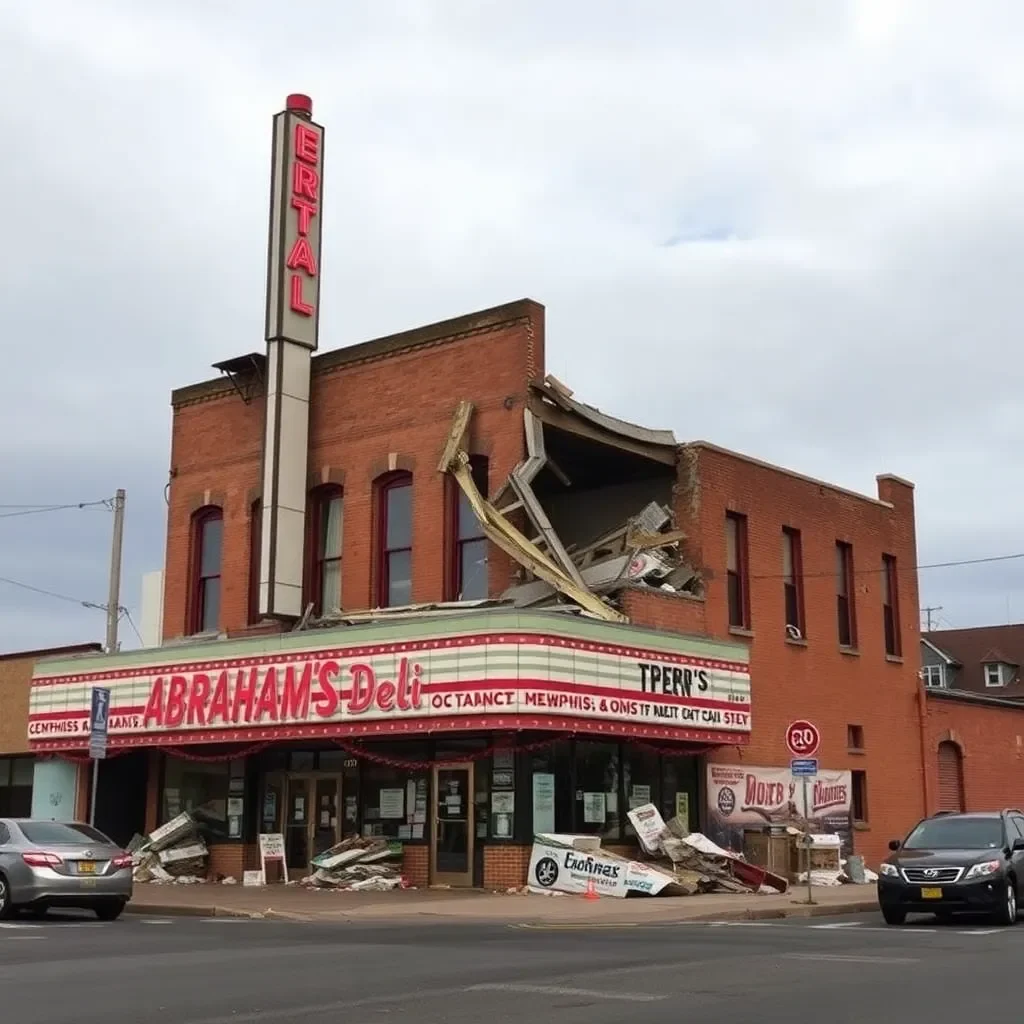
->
(0, 915), (1024, 1024)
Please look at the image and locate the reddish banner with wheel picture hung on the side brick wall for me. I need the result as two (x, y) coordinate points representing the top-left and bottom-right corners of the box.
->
(707, 765), (853, 855)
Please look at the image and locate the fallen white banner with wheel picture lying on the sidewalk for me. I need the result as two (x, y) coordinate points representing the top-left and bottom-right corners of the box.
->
(527, 836), (681, 899)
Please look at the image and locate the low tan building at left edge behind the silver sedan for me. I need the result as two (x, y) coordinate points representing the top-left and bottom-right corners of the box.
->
(0, 644), (102, 821)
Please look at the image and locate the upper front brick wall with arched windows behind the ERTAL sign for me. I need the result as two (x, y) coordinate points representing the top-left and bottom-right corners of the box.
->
(164, 300), (544, 638)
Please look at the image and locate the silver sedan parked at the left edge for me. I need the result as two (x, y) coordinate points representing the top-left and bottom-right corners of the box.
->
(0, 818), (132, 921)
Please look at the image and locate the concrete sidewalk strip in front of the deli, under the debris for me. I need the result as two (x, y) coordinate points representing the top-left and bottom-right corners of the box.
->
(128, 883), (878, 927)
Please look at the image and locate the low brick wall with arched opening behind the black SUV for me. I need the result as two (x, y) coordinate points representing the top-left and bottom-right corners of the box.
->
(925, 697), (1024, 815)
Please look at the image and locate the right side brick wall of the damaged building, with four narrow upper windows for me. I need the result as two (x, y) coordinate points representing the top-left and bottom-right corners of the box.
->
(659, 441), (924, 862)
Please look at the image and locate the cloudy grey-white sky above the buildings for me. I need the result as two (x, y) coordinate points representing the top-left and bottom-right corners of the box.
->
(0, 0), (1024, 650)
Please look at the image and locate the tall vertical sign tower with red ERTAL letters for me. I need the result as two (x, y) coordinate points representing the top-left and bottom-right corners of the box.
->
(259, 93), (324, 618)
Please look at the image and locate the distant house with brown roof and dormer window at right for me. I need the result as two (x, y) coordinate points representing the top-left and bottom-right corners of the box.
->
(921, 625), (1024, 700)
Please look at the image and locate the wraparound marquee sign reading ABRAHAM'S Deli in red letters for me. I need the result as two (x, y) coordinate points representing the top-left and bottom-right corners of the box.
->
(29, 618), (751, 746)
